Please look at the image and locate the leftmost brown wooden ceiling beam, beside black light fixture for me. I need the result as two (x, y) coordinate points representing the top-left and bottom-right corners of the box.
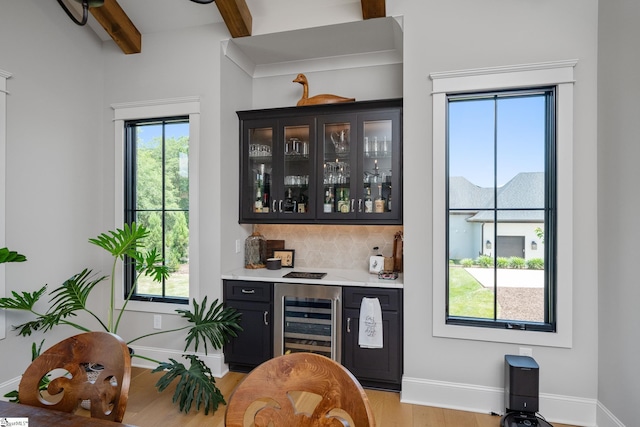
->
(89, 0), (142, 54)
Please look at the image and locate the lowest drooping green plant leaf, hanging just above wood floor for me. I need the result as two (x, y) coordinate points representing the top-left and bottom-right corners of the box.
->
(152, 355), (226, 415)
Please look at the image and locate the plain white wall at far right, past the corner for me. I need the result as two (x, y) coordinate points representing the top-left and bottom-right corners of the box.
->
(598, 0), (640, 426)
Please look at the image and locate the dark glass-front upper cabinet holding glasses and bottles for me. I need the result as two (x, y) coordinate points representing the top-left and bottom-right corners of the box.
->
(237, 99), (402, 224)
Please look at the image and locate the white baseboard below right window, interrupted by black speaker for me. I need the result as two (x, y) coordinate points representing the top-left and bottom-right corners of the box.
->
(401, 376), (596, 427)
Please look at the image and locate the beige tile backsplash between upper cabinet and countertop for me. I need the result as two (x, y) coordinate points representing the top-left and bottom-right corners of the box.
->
(256, 224), (402, 269)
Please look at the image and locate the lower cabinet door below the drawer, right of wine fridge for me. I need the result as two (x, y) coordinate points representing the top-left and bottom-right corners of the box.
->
(342, 309), (402, 390)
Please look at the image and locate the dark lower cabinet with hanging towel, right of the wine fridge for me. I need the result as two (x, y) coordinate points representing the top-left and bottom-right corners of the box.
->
(342, 287), (403, 390)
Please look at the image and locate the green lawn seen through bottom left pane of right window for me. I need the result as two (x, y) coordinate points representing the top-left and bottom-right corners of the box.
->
(449, 266), (493, 319)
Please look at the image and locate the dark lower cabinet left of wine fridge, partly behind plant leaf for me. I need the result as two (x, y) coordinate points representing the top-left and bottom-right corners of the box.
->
(223, 280), (273, 372)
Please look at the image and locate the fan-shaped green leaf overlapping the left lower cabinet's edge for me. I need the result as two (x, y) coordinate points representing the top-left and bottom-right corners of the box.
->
(176, 297), (242, 354)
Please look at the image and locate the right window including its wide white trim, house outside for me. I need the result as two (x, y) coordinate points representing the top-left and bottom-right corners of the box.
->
(430, 61), (576, 347)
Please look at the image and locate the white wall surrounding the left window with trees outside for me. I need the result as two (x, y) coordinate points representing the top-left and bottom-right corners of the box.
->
(101, 24), (232, 354)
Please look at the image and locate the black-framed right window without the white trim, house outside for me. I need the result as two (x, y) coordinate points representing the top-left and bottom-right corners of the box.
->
(446, 87), (556, 331)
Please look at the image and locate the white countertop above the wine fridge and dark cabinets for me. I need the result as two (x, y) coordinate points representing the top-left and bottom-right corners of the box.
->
(222, 268), (404, 288)
